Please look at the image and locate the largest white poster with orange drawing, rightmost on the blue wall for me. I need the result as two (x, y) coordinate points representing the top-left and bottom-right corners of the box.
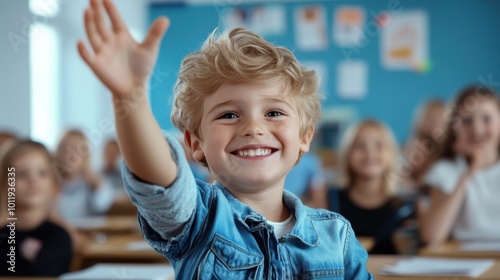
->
(380, 10), (429, 70)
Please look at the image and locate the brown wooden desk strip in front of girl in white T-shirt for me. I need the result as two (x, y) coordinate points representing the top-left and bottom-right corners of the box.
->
(418, 241), (500, 260)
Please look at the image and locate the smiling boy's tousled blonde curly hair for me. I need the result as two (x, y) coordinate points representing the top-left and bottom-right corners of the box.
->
(171, 28), (321, 144)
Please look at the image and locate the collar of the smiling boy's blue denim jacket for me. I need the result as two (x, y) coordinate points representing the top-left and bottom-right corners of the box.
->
(215, 182), (320, 247)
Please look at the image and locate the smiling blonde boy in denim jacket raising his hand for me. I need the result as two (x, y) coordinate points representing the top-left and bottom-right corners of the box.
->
(78, 0), (372, 279)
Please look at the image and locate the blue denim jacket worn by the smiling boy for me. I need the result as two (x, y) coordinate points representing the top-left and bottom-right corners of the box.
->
(122, 135), (373, 280)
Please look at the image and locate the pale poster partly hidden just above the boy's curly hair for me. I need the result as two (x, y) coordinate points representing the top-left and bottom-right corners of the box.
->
(222, 5), (286, 37)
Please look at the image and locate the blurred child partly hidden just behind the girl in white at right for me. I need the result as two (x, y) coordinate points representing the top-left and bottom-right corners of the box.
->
(400, 100), (446, 187)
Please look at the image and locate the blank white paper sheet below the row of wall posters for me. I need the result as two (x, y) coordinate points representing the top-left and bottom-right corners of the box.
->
(335, 60), (368, 99)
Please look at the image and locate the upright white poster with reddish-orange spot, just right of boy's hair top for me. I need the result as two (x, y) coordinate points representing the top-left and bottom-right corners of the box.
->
(295, 5), (328, 51)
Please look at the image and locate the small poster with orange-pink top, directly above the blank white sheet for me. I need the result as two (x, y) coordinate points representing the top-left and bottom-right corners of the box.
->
(333, 6), (365, 47)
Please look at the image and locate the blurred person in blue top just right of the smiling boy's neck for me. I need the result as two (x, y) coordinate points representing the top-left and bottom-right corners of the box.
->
(285, 152), (328, 209)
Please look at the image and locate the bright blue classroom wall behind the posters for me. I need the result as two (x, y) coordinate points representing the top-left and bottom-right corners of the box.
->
(149, 0), (500, 144)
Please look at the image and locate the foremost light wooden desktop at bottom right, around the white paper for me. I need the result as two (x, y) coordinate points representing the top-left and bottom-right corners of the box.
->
(366, 255), (500, 280)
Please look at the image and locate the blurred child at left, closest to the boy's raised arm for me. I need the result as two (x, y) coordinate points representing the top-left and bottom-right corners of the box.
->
(102, 139), (124, 200)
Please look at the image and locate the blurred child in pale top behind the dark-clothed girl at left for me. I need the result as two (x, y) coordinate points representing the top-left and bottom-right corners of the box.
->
(56, 130), (114, 224)
